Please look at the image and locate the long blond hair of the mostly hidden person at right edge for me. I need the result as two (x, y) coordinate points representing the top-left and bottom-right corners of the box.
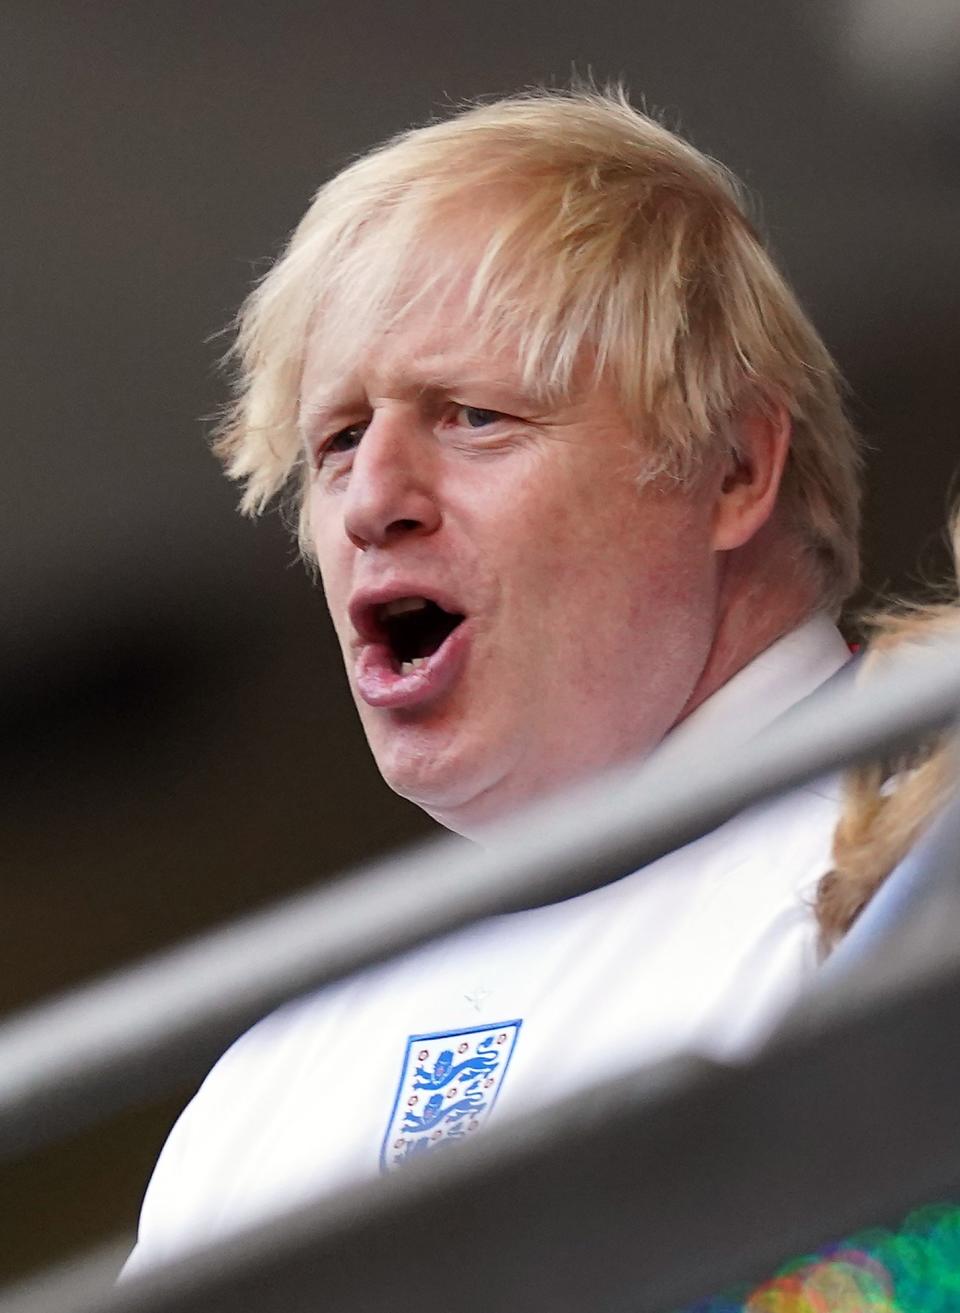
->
(816, 507), (960, 952)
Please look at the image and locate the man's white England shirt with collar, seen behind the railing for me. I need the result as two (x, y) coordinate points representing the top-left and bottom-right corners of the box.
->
(126, 616), (848, 1274)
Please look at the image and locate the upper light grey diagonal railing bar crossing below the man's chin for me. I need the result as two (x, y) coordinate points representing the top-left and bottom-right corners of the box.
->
(0, 638), (960, 1157)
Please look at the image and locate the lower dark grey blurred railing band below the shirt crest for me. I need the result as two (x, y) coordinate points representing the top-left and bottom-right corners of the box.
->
(20, 840), (960, 1313)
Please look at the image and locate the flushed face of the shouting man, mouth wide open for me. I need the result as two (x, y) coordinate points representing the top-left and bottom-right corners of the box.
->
(302, 284), (717, 834)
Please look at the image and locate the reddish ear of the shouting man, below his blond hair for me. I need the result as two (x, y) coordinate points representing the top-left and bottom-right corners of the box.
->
(712, 406), (792, 551)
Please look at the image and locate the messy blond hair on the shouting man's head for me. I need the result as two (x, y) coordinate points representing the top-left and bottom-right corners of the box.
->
(217, 88), (859, 607)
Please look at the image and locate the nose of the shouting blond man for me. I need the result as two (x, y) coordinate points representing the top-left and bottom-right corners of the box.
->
(344, 411), (441, 551)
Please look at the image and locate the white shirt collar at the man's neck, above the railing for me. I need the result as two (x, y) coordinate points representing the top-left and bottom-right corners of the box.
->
(654, 612), (850, 763)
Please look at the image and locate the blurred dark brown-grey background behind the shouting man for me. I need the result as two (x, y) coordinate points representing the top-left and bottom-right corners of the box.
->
(0, 0), (960, 1278)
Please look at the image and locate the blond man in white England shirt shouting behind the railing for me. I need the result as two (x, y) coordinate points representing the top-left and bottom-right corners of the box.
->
(122, 84), (858, 1267)
